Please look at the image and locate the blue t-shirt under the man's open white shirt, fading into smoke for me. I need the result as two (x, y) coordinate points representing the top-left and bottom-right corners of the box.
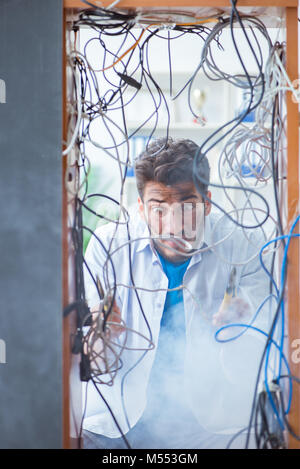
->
(141, 250), (199, 440)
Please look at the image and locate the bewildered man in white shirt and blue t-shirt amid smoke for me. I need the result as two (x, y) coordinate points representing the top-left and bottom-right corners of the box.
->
(84, 139), (270, 448)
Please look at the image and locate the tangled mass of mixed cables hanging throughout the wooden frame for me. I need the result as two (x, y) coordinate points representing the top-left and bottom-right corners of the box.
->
(63, 1), (300, 447)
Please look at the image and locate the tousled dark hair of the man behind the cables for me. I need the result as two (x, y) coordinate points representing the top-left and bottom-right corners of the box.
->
(135, 137), (210, 200)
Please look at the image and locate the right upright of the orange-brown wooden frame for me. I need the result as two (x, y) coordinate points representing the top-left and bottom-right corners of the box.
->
(286, 4), (300, 449)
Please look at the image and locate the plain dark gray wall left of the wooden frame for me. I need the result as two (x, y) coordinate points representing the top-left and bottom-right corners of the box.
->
(0, 0), (62, 448)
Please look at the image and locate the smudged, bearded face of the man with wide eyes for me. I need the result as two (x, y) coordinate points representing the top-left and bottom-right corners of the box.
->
(138, 182), (211, 264)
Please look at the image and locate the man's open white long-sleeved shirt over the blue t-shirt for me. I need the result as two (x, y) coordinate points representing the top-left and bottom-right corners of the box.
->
(83, 209), (271, 438)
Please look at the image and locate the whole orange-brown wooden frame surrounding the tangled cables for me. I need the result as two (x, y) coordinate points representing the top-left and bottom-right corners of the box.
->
(62, 0), (300, 448)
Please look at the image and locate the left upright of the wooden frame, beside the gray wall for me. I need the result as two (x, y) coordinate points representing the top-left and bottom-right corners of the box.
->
(62, 15), (82, 449)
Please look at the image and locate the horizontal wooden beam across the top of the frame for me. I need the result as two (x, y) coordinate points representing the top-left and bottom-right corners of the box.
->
(64, 0), (298, 8)
